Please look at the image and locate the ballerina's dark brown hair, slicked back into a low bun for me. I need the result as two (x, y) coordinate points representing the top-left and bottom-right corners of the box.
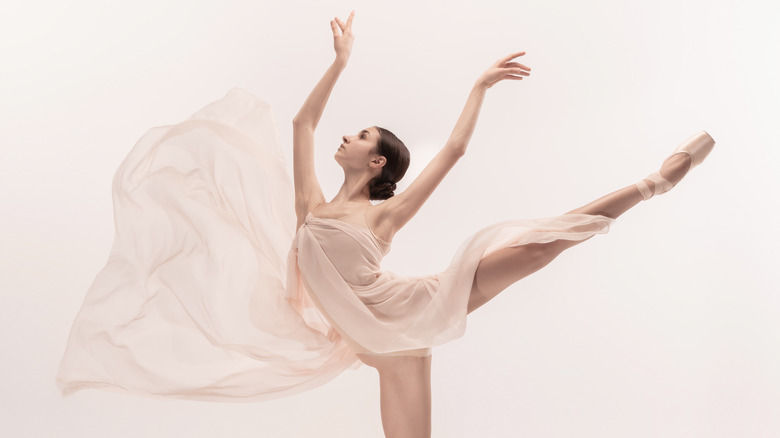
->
(368, 126), (409, 199)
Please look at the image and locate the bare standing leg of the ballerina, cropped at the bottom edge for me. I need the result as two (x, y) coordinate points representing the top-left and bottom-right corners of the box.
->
(358, 354), (432, 438)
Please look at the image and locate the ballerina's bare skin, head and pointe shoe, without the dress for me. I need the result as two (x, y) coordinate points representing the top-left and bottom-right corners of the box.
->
(293, 11), (714, 437)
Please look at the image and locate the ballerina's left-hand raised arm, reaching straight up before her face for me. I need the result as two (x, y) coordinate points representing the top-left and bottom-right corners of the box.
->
(293, 11), (355, 222)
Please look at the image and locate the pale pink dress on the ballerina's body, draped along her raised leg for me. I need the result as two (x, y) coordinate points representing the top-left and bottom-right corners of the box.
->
(294, 214), (614, 356)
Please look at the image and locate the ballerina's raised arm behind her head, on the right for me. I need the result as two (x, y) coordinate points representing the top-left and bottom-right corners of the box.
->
(385, 52), (531, 234)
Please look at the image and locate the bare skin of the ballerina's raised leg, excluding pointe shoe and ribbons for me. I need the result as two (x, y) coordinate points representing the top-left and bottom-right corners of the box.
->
(467, 154), (691, 313)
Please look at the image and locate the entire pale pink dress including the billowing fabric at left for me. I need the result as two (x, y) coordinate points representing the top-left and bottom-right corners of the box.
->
(56, 88), (614, 401)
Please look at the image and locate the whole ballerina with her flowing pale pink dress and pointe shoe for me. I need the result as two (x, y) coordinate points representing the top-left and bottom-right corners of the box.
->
(56, 11), (714, 437)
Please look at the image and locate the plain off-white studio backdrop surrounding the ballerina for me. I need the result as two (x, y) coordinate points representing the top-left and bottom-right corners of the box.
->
(0, 0), (780, 438)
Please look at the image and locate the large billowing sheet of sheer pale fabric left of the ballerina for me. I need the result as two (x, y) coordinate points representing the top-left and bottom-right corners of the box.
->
(56, 88), (361, 401)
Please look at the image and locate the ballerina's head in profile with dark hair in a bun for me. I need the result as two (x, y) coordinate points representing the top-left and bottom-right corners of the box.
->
(335, 126), (409, 199)
